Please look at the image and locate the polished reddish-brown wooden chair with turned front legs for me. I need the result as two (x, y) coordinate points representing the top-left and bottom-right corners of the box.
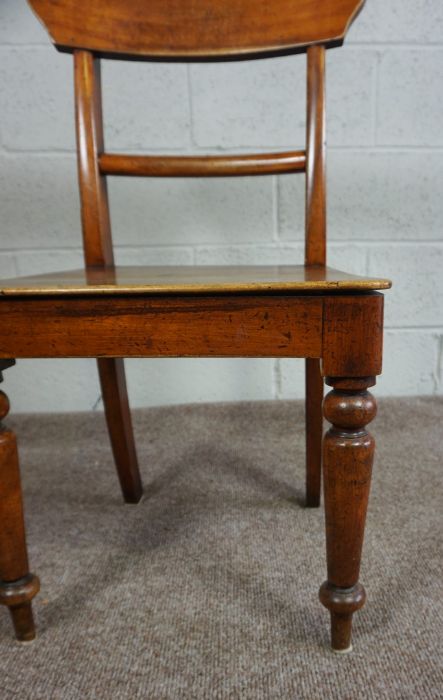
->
(0, 0), (390, 651)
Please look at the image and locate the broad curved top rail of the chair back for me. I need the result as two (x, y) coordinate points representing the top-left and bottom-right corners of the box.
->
(29, 0), (364, 59)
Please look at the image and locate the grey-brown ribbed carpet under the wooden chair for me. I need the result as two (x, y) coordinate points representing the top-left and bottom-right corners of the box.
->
(0, 398), (443, 700)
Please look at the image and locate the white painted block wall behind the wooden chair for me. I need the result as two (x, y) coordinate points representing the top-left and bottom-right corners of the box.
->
(0, 0), (443, 411)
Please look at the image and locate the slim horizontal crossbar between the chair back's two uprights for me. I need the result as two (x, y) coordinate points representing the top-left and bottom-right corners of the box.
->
(99, 151), (306, 177)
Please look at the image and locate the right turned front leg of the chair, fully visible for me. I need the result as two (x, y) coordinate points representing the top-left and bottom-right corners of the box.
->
(320, 378), (376, 652)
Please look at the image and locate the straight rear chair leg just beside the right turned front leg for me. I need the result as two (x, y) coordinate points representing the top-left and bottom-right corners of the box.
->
(306, 359), (323, 508)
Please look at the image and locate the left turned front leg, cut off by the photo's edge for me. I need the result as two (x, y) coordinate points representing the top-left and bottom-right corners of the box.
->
(0, 388), (40, 641)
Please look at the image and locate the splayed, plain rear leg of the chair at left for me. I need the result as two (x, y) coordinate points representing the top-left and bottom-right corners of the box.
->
(97, 357), (143, 503)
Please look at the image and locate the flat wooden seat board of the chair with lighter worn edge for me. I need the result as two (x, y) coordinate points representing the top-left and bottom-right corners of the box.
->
(0, 265), (391, 297)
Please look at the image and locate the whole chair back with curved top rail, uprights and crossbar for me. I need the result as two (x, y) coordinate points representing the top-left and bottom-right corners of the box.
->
(29, 0), (365, 267)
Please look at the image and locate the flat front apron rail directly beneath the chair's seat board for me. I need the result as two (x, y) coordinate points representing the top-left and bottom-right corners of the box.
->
(0, 295), (323, 358)
